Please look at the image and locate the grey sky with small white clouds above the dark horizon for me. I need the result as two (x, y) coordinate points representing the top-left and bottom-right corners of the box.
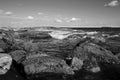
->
(0, 0), (120, 27)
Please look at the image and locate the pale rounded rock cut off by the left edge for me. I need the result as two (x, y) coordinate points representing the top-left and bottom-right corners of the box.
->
(0, 53), (12, 75)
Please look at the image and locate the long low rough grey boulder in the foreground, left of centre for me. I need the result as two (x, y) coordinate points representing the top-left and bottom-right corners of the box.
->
(23, 54), (74, 74)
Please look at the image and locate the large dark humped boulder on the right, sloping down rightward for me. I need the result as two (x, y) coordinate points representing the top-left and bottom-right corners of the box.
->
(73, 41), (119, 72)
